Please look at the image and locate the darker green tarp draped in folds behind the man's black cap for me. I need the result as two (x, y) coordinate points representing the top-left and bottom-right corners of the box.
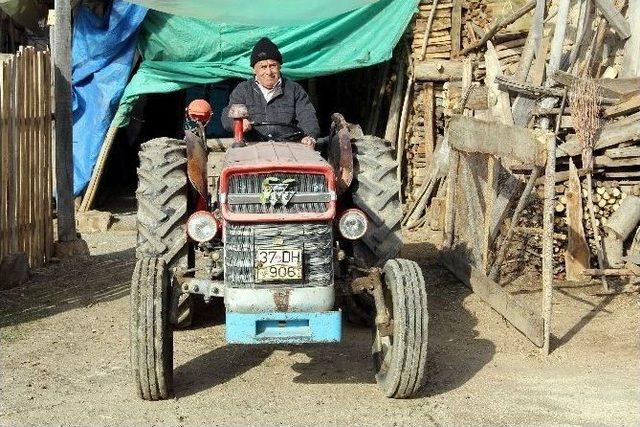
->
(114, 0), (419, 126)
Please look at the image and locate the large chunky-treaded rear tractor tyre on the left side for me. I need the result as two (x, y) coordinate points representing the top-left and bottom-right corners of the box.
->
(136, 138), (193, 328)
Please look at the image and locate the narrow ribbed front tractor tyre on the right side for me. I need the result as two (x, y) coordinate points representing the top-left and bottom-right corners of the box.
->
(371, 259), (429, 399)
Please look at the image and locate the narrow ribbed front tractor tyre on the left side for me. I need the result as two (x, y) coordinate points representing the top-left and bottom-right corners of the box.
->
(129, 257), (173, 400)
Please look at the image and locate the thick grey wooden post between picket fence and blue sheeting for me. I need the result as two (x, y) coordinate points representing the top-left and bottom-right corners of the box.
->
(53, 0), (76, 242)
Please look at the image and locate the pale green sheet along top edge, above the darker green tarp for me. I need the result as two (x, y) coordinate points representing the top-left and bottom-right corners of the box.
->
(122, 0), (377, 25)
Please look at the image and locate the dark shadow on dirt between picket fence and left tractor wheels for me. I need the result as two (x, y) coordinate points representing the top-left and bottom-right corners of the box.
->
(0, 249), (135, 327)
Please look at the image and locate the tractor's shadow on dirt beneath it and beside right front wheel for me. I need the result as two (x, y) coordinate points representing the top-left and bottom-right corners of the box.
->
(175, 239), (495, 397)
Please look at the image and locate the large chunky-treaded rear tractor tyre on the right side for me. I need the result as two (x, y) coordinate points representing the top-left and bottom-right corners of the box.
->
(345, 136), (402, 326)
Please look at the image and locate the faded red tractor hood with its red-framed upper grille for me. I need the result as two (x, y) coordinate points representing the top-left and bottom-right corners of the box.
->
(218, 142), (336, 222)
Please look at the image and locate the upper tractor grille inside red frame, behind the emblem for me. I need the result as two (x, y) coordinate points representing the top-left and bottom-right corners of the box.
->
(227, 173), (331, 214)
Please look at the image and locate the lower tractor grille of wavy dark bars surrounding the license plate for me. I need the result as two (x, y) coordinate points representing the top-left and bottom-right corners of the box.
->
(224, 222), (333, 288)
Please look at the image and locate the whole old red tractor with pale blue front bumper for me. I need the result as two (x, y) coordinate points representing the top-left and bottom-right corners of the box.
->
(130, 101), (428, 400)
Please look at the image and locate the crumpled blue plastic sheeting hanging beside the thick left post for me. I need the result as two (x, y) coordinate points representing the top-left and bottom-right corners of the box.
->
(72, 0), (147, 195)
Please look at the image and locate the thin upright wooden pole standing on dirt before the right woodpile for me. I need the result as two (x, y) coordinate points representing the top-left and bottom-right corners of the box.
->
(542, 135), (556, 354)
